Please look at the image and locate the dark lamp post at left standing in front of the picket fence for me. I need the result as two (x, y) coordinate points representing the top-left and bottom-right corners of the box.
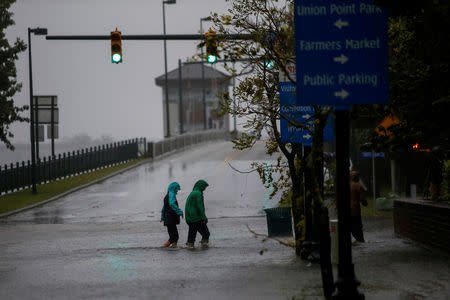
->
(28, 27), (47, 194)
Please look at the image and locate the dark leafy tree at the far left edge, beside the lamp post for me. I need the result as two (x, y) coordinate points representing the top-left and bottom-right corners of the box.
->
(0, 0), (28, 150)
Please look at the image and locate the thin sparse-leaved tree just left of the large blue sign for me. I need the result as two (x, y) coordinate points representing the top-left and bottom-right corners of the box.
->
(206, 0), (331, 255)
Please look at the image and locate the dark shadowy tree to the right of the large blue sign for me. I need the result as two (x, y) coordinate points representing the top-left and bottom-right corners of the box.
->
(353, 0), (450, 198)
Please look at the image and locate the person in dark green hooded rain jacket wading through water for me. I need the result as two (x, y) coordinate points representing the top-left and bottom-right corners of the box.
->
(184, 180), (209, 249)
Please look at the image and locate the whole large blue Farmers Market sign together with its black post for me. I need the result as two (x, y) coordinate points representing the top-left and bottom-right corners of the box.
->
(294, 0), (389, 299)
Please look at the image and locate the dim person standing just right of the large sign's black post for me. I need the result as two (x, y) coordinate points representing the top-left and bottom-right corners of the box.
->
(350, 171), (367, 243)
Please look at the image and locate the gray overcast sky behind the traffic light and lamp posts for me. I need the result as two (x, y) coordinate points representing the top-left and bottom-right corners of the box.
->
(7, 0), (229, 142)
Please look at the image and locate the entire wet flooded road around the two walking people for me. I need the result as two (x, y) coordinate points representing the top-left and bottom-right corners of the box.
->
(0, 142), (450, 300)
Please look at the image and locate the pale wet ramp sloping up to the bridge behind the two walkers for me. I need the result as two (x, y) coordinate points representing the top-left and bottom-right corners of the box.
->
(7, 142), (278, 224)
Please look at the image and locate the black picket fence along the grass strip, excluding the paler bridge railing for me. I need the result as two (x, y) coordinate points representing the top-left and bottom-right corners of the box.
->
(0, 138), (141, 194)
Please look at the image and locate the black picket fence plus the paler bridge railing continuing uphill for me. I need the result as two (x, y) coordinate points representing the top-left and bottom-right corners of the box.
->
(0, 130), (230, 195)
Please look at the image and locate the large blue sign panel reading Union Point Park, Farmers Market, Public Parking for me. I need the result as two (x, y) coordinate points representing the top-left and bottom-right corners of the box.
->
(295, 0), (389, 105)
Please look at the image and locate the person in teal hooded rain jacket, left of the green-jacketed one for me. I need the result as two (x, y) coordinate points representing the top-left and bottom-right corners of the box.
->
(161, 182), (183, 248)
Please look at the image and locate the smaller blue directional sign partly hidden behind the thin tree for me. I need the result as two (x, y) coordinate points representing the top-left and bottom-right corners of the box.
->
(279, 82), (334, 146)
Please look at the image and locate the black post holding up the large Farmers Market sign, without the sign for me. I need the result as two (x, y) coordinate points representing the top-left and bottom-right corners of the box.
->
(333, 110), (364, 300)
